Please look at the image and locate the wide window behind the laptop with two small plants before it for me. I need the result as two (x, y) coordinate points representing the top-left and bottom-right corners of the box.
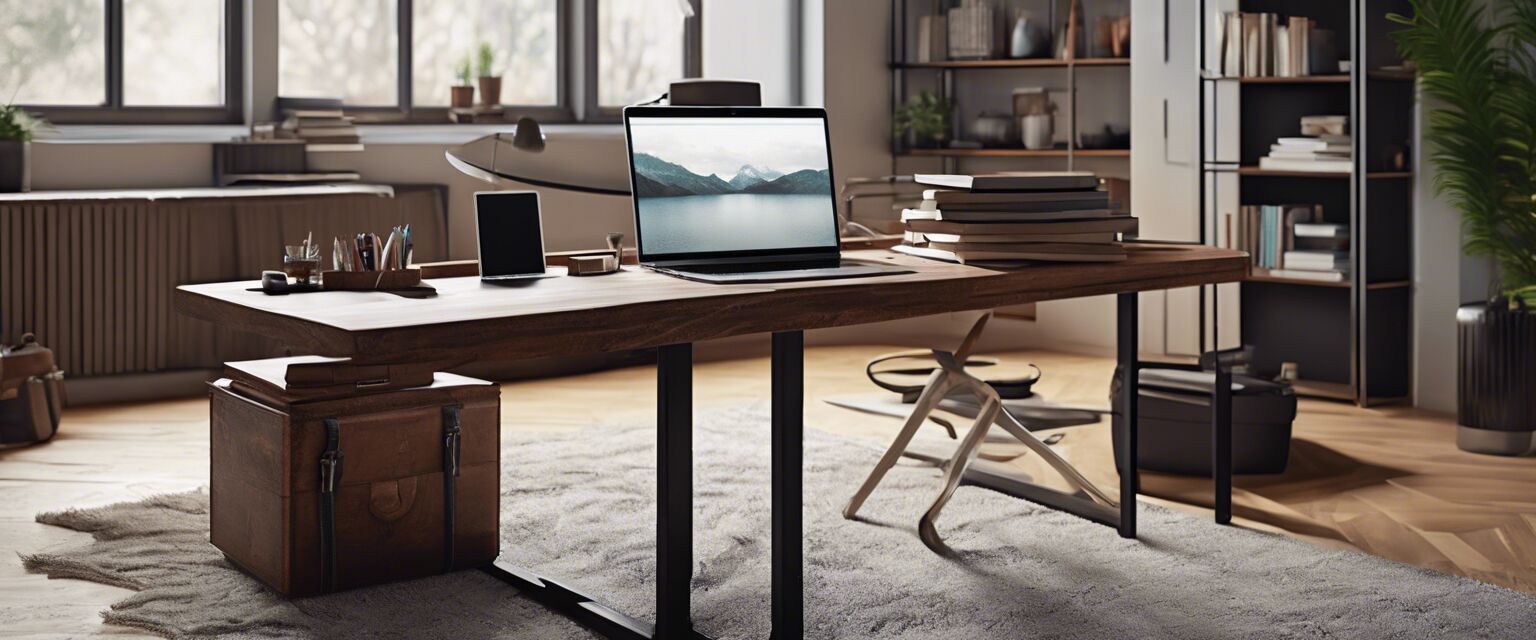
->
(278, 0), (699, 123)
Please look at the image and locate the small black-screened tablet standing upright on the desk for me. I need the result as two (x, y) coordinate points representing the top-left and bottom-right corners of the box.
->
(475, 192), (556, 276)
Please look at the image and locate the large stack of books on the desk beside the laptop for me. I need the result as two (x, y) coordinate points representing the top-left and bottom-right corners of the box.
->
(894, 172), (1137, 266)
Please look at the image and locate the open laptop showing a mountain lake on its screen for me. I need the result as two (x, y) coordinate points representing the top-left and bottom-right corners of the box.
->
(624, 106), (908, 282)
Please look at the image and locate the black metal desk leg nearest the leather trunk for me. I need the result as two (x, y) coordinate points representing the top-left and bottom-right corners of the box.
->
(656, 344), (693, 638)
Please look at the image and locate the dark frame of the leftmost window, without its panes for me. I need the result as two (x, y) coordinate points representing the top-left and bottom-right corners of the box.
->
(22, 0), (246, 124)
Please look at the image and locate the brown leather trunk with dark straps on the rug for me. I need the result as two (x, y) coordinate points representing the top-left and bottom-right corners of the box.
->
(209, 359), (501, 597)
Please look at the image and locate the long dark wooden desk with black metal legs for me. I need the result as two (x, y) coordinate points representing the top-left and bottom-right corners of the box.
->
(175, 244), (1249, 640)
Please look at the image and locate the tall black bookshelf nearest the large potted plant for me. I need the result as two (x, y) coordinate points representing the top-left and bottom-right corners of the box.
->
(1197, 0), (1415, 405)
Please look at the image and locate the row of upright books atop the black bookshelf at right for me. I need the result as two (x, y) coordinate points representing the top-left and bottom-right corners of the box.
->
(1212, 11), (1339, 78)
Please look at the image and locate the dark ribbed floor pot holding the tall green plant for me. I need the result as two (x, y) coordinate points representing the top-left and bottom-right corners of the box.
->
(1456, 299), (1536, 456)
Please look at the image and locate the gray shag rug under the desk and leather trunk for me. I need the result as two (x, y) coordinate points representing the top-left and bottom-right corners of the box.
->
(25, 407), (1536, 640)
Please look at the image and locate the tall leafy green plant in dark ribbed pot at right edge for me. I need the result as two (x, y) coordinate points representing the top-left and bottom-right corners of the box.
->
(1389, 0), (1536, 454)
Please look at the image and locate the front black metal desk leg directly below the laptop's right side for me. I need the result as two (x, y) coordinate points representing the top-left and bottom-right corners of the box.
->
(773, 332), (805, 640)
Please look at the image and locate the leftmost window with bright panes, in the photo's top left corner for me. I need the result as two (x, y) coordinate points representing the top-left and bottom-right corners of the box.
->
(0, 0), (240, 123)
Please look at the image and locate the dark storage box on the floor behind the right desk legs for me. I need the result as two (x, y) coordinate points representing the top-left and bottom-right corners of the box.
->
(1111, 368), (1296, 476)
